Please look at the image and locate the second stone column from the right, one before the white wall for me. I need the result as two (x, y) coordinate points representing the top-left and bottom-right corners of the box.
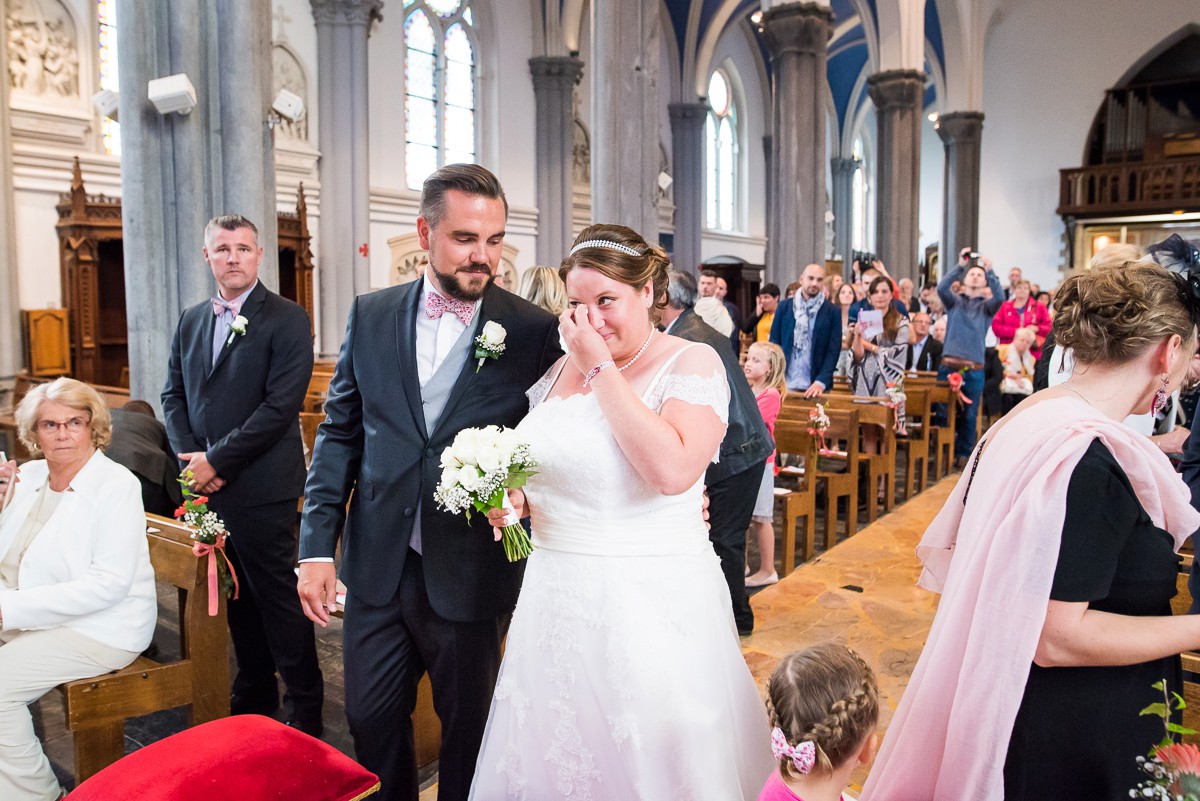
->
(866, 70), (925, 281)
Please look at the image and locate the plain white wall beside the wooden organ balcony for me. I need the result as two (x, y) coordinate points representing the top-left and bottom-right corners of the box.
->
(979, 0), (1200, 287)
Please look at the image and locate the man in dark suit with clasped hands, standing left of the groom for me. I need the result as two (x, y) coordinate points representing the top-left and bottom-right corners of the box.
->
(162, 215), (324, 736)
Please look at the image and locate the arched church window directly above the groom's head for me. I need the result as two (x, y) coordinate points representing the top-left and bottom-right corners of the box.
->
(404, 0), (476, 189)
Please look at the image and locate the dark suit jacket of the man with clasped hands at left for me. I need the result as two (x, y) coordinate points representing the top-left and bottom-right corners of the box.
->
(162, 283), (312, 506)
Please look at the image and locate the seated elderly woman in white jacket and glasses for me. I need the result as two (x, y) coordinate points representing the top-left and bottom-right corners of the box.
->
(0, 378), (157, 801)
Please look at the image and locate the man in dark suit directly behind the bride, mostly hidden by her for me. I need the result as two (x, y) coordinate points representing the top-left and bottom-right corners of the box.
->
(662, 269), (775, 637)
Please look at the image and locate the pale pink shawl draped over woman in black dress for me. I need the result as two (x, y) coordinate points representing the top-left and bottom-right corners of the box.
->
(863, 398), (1200, 801)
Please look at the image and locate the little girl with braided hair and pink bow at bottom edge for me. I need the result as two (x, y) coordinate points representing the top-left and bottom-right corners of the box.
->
(758, 643), (880, 801)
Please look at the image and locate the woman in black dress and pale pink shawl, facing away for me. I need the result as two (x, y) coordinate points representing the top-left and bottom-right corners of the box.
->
(863, 264), (1200, 801)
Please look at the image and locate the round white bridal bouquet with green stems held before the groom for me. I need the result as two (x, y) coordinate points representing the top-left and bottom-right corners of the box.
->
(433, 426), (538, 562)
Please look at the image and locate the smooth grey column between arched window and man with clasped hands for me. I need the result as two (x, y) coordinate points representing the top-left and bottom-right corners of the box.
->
(310, 0), (383, 357)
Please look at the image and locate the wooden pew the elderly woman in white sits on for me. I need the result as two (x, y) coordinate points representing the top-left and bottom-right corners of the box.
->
(59, 514), (229, 783)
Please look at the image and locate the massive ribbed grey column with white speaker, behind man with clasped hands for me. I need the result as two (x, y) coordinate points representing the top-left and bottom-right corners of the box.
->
(116, 0), (278, 405)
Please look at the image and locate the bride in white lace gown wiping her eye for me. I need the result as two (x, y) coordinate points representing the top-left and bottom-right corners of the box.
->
(470, 225), (773, 801)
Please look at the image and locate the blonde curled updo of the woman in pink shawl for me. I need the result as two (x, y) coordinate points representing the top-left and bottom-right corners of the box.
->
(1054, 261), (1200, 365)
